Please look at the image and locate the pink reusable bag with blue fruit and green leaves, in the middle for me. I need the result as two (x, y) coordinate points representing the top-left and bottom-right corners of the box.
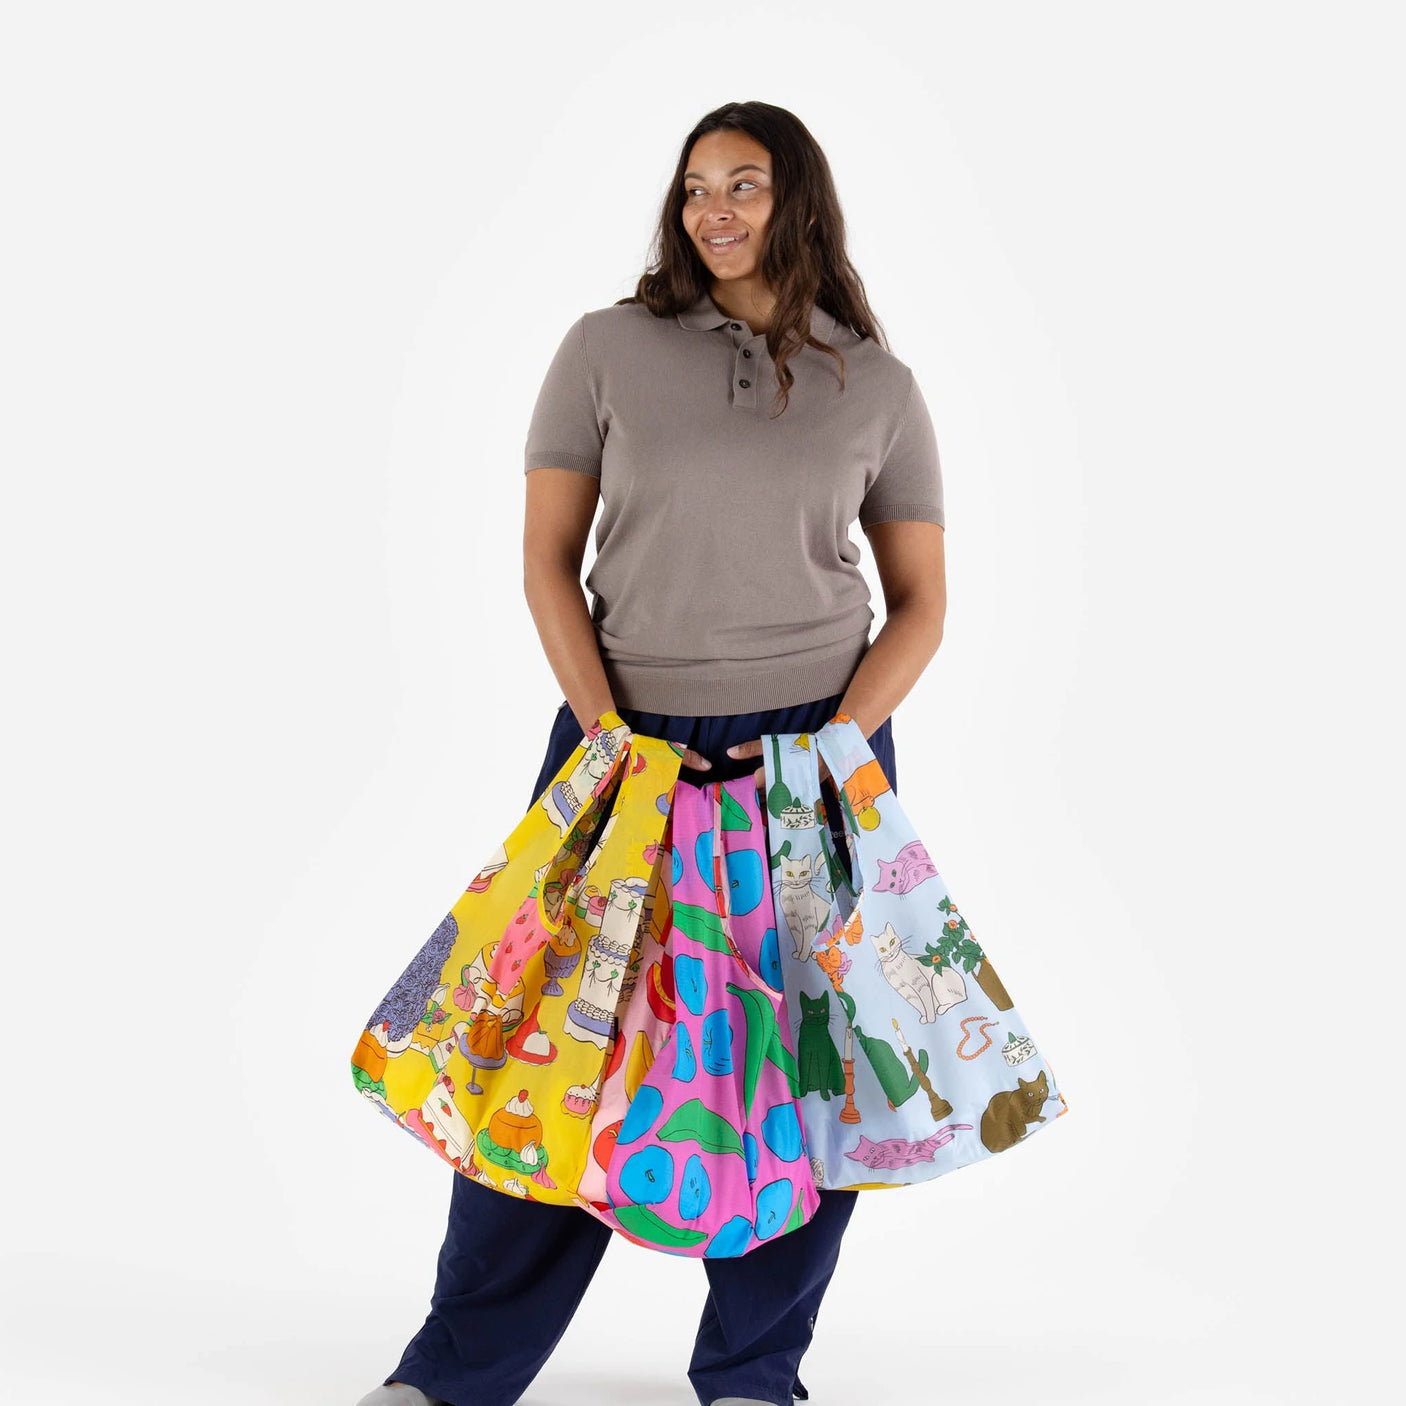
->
(589, 775), (820, 1258)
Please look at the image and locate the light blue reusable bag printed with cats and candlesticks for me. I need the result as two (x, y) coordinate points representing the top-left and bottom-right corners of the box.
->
(762, 713), (1066, 1191)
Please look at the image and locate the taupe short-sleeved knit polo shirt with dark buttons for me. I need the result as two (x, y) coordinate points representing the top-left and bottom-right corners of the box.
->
(524, 286), (945, 714)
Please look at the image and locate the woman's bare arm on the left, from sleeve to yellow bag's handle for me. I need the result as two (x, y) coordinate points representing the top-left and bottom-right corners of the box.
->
(523, 465), (616, 735)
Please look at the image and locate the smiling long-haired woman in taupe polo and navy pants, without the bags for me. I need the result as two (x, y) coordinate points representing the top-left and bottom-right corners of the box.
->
(361, 103), (946, 1406)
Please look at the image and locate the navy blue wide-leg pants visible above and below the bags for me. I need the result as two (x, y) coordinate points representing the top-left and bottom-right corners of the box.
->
(384, 693), (898, 1406)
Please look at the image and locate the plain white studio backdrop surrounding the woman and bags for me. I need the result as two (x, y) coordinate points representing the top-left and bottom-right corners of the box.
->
(0, 0), (1406, 1406)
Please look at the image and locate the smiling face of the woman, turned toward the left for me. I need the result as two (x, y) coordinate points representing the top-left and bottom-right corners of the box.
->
(683, 128), (772, 280)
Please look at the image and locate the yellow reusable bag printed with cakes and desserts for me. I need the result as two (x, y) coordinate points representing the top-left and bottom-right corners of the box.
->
(352, 711), (682, 1205)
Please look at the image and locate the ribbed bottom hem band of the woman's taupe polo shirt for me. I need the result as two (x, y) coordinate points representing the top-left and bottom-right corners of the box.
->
(600, 626), (869, 717)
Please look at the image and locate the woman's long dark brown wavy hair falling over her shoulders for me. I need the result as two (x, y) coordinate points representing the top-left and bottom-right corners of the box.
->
(617, 103), (889, 415)
